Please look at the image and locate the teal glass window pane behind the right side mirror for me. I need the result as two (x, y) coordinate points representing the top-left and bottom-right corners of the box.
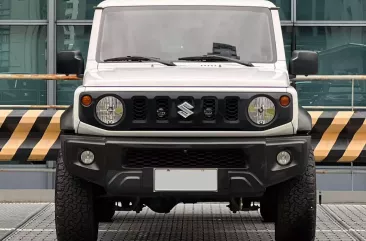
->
(297, 27), (366, 75)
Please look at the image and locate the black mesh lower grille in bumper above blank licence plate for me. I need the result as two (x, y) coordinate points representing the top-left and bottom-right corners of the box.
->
(122, 148), (246, 168)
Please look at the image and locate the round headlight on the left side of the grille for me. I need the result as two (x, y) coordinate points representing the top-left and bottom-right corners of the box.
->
(96, 96), (124, 125)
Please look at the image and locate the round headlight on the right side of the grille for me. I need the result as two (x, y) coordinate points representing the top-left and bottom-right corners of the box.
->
(248, 96), (276, 125)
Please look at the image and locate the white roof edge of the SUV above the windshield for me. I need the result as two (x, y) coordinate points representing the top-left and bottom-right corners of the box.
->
(98, 0), (276, 8)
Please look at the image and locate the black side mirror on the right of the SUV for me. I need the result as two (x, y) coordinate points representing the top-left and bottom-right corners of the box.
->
(289, 50), (318, 75)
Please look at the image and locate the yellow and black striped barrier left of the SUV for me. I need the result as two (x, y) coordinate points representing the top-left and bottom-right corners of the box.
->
(0, 110), (64, 163)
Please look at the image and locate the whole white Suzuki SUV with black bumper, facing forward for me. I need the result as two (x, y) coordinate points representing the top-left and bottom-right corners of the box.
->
(56, 0), (318, 241)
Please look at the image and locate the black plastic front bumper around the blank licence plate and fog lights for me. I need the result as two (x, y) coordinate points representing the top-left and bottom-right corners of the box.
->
(61, 135), (311, 197)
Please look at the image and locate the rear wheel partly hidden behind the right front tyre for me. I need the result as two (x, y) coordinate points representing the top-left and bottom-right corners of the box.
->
(259, 187), (277, 222)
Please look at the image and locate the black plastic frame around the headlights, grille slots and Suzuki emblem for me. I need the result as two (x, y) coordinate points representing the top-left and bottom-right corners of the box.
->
(79, 91), (293, 131)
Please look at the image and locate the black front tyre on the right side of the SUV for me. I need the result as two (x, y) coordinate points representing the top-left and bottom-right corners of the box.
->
(275, 151), (316, 241)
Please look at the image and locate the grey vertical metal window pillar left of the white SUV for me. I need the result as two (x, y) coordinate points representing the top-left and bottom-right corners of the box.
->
(47, 0), (56, 105)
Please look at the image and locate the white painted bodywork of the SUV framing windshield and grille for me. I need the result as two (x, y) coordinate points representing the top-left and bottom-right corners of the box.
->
(74, 0), (298, 137)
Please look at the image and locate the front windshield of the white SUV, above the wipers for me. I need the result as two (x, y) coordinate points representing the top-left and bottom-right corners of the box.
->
(98, 6), (276, 63)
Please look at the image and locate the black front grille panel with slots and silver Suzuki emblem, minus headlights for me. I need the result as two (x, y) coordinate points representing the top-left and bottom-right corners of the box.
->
(79, 91), (293, 131)
